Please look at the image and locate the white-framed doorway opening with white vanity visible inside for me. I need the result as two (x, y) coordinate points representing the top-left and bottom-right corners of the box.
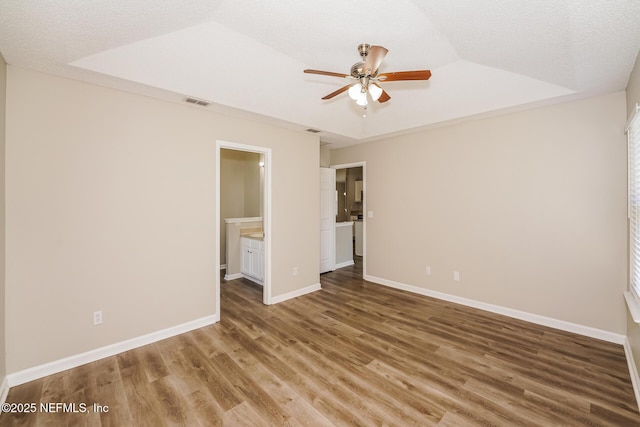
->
(215, 141), (271, 316)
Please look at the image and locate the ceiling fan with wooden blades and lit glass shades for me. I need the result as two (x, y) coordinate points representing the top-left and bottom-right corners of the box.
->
(304, 43), (431, 108)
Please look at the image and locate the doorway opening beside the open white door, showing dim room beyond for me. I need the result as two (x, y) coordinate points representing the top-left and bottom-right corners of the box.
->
(331, 162), (367, 276)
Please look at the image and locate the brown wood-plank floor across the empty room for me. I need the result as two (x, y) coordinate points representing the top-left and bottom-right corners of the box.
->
(0, 264), (640, 427)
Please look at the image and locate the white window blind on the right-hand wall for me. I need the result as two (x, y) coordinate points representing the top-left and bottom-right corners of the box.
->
(627, 105), (640, 298)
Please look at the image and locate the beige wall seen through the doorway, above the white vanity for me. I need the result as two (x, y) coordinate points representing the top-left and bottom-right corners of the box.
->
(220, 149), (262, 265)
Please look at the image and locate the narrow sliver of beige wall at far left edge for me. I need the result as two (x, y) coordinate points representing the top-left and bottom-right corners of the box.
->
(0, 54), (7, 384)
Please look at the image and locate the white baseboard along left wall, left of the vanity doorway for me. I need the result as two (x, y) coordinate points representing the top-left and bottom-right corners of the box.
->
(7, 314), (220, 387)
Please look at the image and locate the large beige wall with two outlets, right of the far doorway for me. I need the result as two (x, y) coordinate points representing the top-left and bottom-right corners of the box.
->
(331, 93), (627, 334)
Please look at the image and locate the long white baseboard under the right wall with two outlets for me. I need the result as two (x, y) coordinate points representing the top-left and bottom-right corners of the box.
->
(364, 275), (626, 344)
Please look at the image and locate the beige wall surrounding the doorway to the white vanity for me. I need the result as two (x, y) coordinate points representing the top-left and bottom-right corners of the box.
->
(6, 66), (319, 373)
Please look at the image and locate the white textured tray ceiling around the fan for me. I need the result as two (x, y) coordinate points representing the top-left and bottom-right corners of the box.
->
(0, 0), (640, 147)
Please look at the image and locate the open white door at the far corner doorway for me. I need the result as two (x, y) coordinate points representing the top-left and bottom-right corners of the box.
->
(320, 168), (336, 273)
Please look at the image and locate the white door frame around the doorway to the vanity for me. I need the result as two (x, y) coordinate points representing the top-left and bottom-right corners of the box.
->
(214, 140), (272, 319)
